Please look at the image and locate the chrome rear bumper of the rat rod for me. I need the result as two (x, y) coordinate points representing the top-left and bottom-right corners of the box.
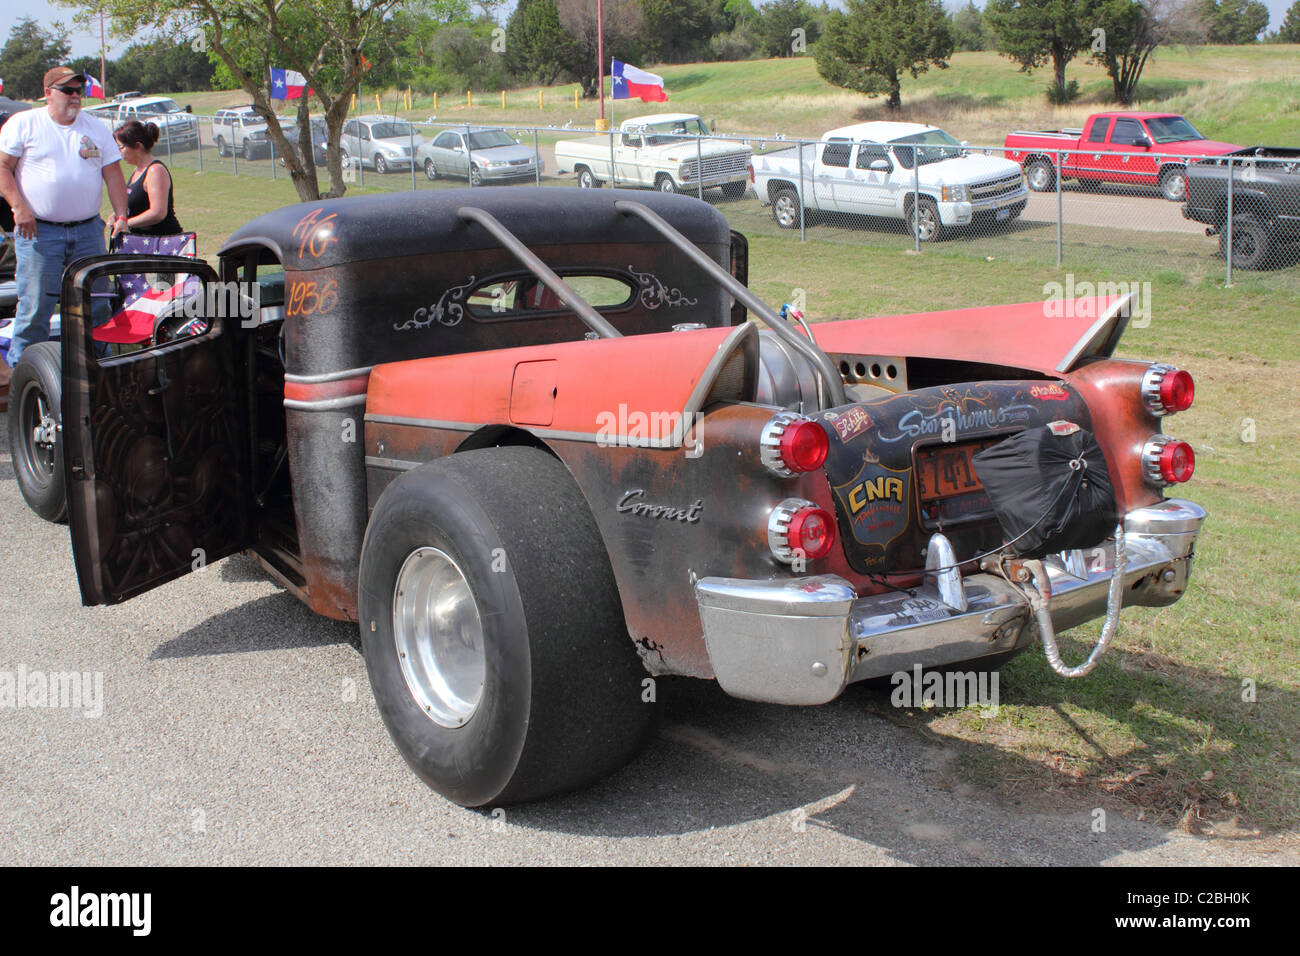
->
(696, 498), (1205, 704)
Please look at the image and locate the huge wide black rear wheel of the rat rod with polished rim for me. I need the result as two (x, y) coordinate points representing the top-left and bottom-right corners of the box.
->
(359, 447), (654, 806)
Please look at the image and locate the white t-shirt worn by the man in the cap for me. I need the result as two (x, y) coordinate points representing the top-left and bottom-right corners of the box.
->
(0, 109), (122, 222)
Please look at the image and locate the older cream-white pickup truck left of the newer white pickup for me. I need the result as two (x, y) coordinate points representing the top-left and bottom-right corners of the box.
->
(555, 113), (759, 199)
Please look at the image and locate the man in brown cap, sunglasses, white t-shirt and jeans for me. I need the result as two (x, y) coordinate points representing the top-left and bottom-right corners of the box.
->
(0, 66), (126, 367)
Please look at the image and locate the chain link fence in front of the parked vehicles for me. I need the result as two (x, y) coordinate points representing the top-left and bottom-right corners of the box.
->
(155, 117), (1300, 291)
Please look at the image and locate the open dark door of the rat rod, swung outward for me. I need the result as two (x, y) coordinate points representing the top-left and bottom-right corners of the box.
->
(62, 255), (254, 605)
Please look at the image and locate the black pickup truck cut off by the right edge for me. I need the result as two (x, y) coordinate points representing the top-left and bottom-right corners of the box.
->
(1183, 146), (1300, 269)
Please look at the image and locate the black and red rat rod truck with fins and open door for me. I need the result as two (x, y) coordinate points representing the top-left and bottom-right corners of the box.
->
(32, 187), (1205, 805)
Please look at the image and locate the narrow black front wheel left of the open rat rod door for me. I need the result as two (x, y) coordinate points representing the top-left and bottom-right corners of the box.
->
(9, 342), (68, 522)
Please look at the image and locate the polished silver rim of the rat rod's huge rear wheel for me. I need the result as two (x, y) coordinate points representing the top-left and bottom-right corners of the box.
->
(393, 548), (488, 728)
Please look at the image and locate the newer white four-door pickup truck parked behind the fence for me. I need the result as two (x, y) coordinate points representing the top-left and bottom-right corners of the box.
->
(753, 122), (1030, 242)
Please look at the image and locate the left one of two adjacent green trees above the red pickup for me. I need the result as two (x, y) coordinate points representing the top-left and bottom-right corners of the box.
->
(984, 0), (1096, 103)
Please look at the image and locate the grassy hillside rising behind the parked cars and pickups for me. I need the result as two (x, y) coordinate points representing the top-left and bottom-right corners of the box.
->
(177, 44), (1300, 144)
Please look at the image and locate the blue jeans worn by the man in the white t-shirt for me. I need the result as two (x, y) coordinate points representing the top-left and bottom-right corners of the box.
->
(9, 216), (105, 365)
